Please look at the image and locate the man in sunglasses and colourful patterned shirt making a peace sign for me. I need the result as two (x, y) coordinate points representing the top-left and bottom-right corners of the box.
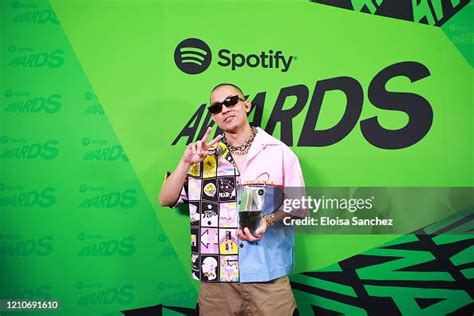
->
(160, 83), (307, 316)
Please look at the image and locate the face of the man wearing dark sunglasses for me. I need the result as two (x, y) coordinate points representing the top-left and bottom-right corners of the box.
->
(211, 86), (251, 132)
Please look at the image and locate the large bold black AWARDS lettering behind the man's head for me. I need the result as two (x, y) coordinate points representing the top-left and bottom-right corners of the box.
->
(172, 61), (434, 149)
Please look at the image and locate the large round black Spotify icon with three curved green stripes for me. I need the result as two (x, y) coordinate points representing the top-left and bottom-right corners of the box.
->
(174, 38), (212, 75)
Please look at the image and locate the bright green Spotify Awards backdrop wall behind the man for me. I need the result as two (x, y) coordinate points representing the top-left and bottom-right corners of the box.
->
(0, 0), (474, 315)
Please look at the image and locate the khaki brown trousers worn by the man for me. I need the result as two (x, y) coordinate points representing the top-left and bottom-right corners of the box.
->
(199, 276), (296, 316)
